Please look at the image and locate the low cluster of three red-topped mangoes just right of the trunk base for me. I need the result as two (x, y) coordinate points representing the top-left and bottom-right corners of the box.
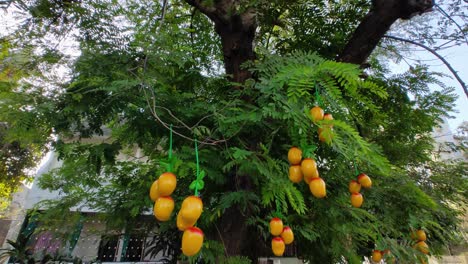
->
(270, 217), (294, 257)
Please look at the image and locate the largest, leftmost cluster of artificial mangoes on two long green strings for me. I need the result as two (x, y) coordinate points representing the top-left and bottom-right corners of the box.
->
(150, 172), (204, 257)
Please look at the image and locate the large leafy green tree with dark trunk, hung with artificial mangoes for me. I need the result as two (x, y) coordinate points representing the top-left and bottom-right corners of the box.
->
(2, 0), (466, 263)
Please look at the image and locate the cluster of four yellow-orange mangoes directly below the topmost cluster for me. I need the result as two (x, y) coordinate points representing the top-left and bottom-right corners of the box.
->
(288, 147), (327, 198)
